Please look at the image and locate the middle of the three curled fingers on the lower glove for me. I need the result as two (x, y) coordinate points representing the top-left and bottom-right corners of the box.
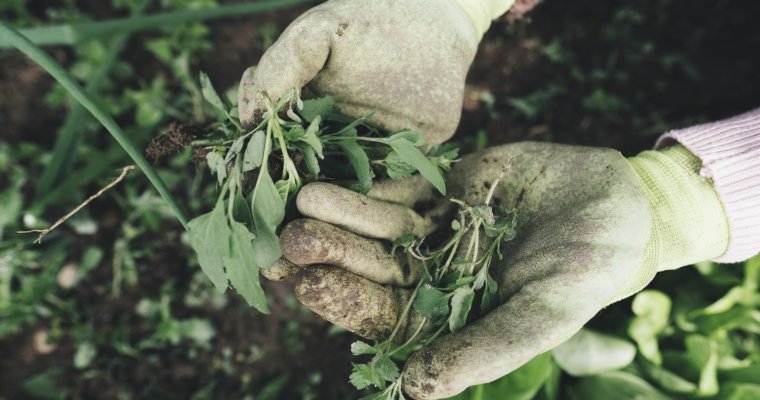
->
(280, 219), (422, 287)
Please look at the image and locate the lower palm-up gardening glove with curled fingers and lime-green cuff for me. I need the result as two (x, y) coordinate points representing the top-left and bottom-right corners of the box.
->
(280, 142), (728, 399)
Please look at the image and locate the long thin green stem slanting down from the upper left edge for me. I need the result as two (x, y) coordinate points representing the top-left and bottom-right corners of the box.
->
(0, 21), (187, 229)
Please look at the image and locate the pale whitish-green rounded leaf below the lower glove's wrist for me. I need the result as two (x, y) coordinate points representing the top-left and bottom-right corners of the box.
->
(552, 329), (636, 376)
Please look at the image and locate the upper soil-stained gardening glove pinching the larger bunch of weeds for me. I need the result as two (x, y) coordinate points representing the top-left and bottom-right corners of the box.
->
(238, 0), (513, 144)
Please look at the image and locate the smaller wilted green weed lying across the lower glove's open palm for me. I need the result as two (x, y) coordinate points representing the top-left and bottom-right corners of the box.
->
(350, 182), (517, 400)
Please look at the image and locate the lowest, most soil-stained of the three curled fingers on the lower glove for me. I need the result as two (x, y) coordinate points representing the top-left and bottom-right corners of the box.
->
(295, 266), (427, 342)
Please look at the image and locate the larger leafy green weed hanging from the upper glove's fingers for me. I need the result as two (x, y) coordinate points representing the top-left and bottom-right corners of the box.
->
(188, 73), (458, 312)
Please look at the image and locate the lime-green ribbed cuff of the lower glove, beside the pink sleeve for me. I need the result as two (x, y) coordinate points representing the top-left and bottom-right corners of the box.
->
(620, 145), (729, 298)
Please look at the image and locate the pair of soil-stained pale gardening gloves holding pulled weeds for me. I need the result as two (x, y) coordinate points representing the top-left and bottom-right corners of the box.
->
(239, 0), (728, 399)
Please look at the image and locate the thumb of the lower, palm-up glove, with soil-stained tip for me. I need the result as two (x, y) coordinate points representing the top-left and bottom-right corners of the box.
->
(404, 256), (619, 400)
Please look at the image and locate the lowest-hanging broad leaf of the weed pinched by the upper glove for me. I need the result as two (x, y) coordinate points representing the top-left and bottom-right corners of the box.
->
(224, 221), (269, 314)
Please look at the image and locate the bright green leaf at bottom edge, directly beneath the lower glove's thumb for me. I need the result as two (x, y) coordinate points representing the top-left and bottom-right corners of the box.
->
(448, 353), (556, 400)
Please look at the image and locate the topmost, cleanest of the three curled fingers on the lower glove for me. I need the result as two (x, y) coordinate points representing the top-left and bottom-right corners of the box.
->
(296, 182), (436, 240)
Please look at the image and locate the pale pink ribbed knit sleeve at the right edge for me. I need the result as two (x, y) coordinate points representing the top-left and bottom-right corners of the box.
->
(656, 108), (760, 263)
